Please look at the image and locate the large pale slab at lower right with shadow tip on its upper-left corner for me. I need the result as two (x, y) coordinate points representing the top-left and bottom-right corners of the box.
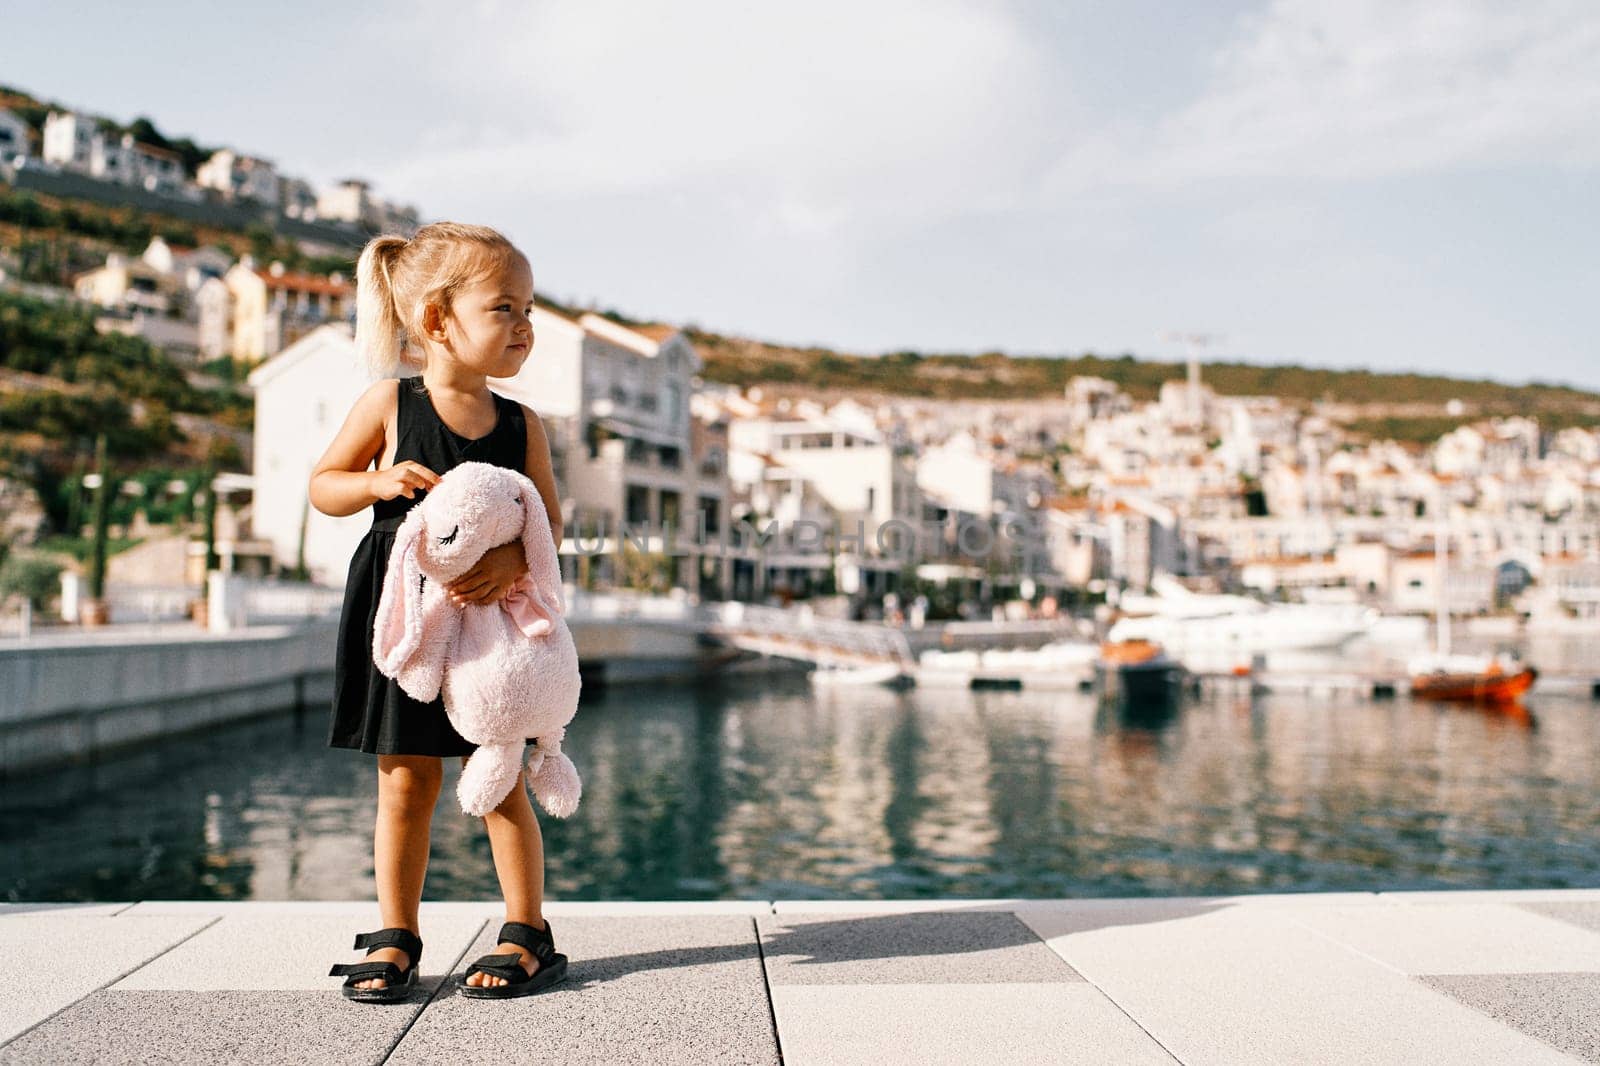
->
(1019, 900), (1571, 1066)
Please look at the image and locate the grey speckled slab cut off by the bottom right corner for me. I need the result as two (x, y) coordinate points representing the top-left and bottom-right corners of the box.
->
(1422, 973), (1600, 1063)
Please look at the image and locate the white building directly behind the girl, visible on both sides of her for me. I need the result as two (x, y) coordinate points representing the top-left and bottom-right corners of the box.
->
(249, 312), (732, 594)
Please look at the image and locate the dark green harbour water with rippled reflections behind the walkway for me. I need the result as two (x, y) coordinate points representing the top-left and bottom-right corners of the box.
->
(0, 680), (1600, 900)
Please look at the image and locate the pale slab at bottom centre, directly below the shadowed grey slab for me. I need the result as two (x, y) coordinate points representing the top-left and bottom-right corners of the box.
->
(773, 981), (1178, 1066)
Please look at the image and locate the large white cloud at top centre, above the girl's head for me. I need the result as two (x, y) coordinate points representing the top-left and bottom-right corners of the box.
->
(387, 0), (1066, 235)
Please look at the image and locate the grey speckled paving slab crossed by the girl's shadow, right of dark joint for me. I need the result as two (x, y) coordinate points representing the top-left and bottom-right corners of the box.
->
(755, 912), (1083, 985)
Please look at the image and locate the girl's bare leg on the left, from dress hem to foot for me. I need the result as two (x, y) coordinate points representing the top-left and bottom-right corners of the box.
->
(355, 755), (445, 988)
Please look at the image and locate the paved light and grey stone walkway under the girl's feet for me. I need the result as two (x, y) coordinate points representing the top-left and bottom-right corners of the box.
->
(0, 890), (1600, 1066)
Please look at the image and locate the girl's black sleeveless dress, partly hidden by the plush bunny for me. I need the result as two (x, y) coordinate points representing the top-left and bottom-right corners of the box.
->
(328, 378), (528, 755)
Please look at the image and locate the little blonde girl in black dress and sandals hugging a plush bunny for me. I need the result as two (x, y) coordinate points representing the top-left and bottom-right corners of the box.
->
(309, 222), (566, 1004)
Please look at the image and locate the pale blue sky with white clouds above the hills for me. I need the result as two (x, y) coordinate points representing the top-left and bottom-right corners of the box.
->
(0, 0), (1600, 389)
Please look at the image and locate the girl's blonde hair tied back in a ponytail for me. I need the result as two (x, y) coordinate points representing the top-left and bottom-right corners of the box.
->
(355, 222), (522, 378)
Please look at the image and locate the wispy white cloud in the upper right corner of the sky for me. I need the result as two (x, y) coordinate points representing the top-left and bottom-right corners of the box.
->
(1136, 0), (1600, 179)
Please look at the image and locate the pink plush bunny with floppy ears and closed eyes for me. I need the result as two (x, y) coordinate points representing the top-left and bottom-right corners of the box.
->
(373, 463), (582, 818)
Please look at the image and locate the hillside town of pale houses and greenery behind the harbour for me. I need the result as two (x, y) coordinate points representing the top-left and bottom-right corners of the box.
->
(0, 90), (1600, 630)
